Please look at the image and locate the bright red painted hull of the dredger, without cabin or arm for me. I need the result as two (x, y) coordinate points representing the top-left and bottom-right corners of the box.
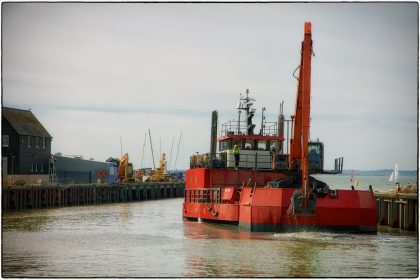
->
(183, 169), (377, 232)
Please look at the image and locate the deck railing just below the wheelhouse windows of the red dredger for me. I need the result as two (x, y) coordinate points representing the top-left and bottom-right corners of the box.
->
(190, 152), (273, 170)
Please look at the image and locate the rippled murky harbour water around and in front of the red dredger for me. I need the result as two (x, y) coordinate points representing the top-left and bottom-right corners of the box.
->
(2, 194), (418, 278)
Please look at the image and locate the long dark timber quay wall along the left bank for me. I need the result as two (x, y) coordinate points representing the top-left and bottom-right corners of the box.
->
(2, 182), (185, 211)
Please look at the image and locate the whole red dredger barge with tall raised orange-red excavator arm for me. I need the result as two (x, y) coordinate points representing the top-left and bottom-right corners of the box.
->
(183, 23), (377, 233)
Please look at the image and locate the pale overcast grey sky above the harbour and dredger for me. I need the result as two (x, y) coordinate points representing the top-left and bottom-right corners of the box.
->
(2, 2), (418, 170)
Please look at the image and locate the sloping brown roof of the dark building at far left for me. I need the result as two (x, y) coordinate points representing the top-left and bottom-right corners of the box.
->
(2, 107), (52, 138)
